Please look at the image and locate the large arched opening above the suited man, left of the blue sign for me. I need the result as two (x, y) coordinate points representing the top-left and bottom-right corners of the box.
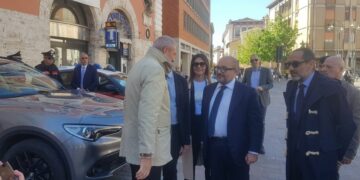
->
(50, 0), (90, 66)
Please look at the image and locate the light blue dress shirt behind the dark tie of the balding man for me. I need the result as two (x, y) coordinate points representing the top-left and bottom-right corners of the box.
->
(209, 79), (235, 137)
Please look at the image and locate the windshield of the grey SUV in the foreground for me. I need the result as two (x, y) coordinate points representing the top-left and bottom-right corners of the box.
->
(0, 61), (61, 98)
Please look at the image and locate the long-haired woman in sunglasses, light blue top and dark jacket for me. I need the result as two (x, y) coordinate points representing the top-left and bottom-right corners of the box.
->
(183, 54), (211, 179)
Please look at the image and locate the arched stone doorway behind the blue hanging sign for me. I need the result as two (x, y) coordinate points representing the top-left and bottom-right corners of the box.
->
(106, 10), (132, 73)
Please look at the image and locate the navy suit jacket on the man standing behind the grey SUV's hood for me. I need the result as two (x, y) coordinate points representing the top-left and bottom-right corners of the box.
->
(71, 64), (99, 91)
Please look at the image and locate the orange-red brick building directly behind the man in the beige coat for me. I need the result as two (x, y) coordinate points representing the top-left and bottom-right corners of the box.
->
(162, 0), (211, 75)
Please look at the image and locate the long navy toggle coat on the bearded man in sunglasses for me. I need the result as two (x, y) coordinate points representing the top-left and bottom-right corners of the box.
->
(284, 72), (355, 176)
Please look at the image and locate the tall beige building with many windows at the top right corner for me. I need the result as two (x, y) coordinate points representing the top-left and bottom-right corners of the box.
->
(267, 0), (360, 71)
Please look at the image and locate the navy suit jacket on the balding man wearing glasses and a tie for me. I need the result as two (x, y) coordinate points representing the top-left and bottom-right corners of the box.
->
(202, 81), (264, 166)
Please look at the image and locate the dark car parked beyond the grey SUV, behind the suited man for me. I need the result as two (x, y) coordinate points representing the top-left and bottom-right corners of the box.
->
(59, 66), (127, 100)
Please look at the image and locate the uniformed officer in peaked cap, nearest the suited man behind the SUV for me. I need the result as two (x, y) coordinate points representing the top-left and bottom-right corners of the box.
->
(35, 50), (63, 84)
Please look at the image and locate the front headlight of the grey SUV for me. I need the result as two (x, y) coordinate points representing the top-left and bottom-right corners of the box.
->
(64, 124), (121, 141)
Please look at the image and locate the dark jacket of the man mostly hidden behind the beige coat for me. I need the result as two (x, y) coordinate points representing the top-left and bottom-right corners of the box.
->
(173, 72), (190, 146)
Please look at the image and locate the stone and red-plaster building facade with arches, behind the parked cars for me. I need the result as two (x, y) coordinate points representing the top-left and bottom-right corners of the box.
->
(0, 0), (162, 73)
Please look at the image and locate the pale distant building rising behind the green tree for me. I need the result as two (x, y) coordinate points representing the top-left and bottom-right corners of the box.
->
(222, 18), (264, 58)
